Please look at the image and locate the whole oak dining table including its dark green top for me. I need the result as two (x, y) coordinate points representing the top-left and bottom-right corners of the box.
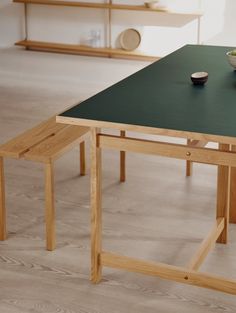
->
(57, 45), (236, 294)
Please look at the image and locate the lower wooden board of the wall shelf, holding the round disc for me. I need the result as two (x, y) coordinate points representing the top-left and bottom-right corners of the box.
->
(16, 40), (160, 61)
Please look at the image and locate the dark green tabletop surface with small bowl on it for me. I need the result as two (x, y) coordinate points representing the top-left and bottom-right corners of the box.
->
(61, 45), (236, 137)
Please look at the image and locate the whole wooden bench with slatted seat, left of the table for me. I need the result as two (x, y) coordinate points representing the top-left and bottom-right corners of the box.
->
(0, 117), (89, 250)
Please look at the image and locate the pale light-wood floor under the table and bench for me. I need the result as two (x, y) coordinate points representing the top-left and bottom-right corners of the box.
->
(0, 49), (236, 313)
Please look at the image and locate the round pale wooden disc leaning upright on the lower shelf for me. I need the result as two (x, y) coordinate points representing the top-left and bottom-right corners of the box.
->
(120, 28), (141, 51)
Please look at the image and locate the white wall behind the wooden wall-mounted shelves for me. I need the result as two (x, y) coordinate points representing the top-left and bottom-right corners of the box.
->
(0, 0), (236, 55)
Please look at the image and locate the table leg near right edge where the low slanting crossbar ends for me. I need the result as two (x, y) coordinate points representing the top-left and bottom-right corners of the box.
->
(216, 144), (231, 243)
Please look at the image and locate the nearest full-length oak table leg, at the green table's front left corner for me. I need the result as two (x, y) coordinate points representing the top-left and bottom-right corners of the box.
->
(90, 128), (102, 283)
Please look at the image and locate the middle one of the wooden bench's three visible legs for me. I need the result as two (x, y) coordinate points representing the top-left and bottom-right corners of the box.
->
(45, 163), (55, 251)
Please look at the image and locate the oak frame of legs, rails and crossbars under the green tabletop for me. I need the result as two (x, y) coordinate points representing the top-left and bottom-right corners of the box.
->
(88, 126), (236, 294)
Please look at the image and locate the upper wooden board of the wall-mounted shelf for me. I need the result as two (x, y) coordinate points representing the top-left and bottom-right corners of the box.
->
(13, 0), (202, 17)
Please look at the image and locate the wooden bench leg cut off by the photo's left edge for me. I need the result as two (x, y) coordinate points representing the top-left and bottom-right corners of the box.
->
(0, 157), (7, 240)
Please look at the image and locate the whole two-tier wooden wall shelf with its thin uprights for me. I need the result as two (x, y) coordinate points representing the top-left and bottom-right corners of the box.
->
(13, 0), (202, 61)
